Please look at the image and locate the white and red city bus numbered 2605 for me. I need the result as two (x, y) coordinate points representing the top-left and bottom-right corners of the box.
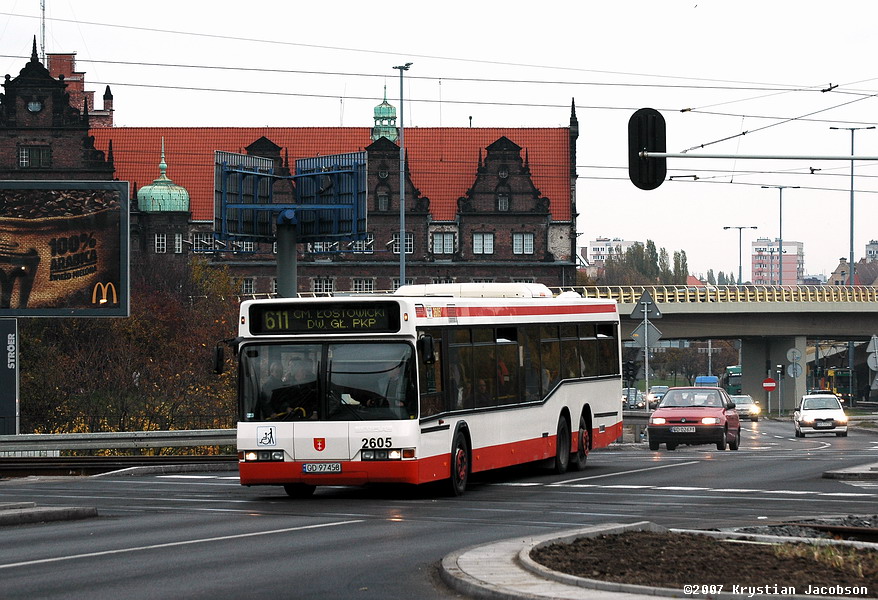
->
(230, 284), (622, 497)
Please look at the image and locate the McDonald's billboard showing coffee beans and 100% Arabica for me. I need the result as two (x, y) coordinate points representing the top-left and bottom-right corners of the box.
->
(0, 180), (129, 317)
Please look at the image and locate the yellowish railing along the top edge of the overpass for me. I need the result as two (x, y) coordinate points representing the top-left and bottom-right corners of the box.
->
(552, 285), (878, 304)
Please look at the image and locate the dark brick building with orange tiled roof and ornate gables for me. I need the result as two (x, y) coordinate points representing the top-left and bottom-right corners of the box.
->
(0, 42), (579, 295)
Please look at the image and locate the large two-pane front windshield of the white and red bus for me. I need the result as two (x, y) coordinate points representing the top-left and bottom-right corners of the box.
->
(239, 342), (418, 421)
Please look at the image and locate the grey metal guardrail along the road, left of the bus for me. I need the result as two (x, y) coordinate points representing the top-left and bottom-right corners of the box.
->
(0, 429), (237, 453)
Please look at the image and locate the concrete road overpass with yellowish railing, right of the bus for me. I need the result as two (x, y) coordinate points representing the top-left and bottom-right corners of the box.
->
(555, 285), (878, 410)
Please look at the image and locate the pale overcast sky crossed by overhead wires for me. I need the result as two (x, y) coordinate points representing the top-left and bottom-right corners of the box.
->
(0, 0), (878, 280)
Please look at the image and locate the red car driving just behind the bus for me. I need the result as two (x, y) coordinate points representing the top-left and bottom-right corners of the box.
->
(646, 387), (741, 450)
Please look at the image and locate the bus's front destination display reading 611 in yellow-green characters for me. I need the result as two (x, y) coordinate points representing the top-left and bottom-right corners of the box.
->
(250, 302), (399, 335)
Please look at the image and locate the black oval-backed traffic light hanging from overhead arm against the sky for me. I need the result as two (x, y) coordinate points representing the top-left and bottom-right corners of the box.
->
(628, 108), (668, 190)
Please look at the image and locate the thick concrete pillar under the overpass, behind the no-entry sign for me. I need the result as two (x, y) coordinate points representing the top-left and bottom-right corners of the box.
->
(741, 336), (807, 416)
